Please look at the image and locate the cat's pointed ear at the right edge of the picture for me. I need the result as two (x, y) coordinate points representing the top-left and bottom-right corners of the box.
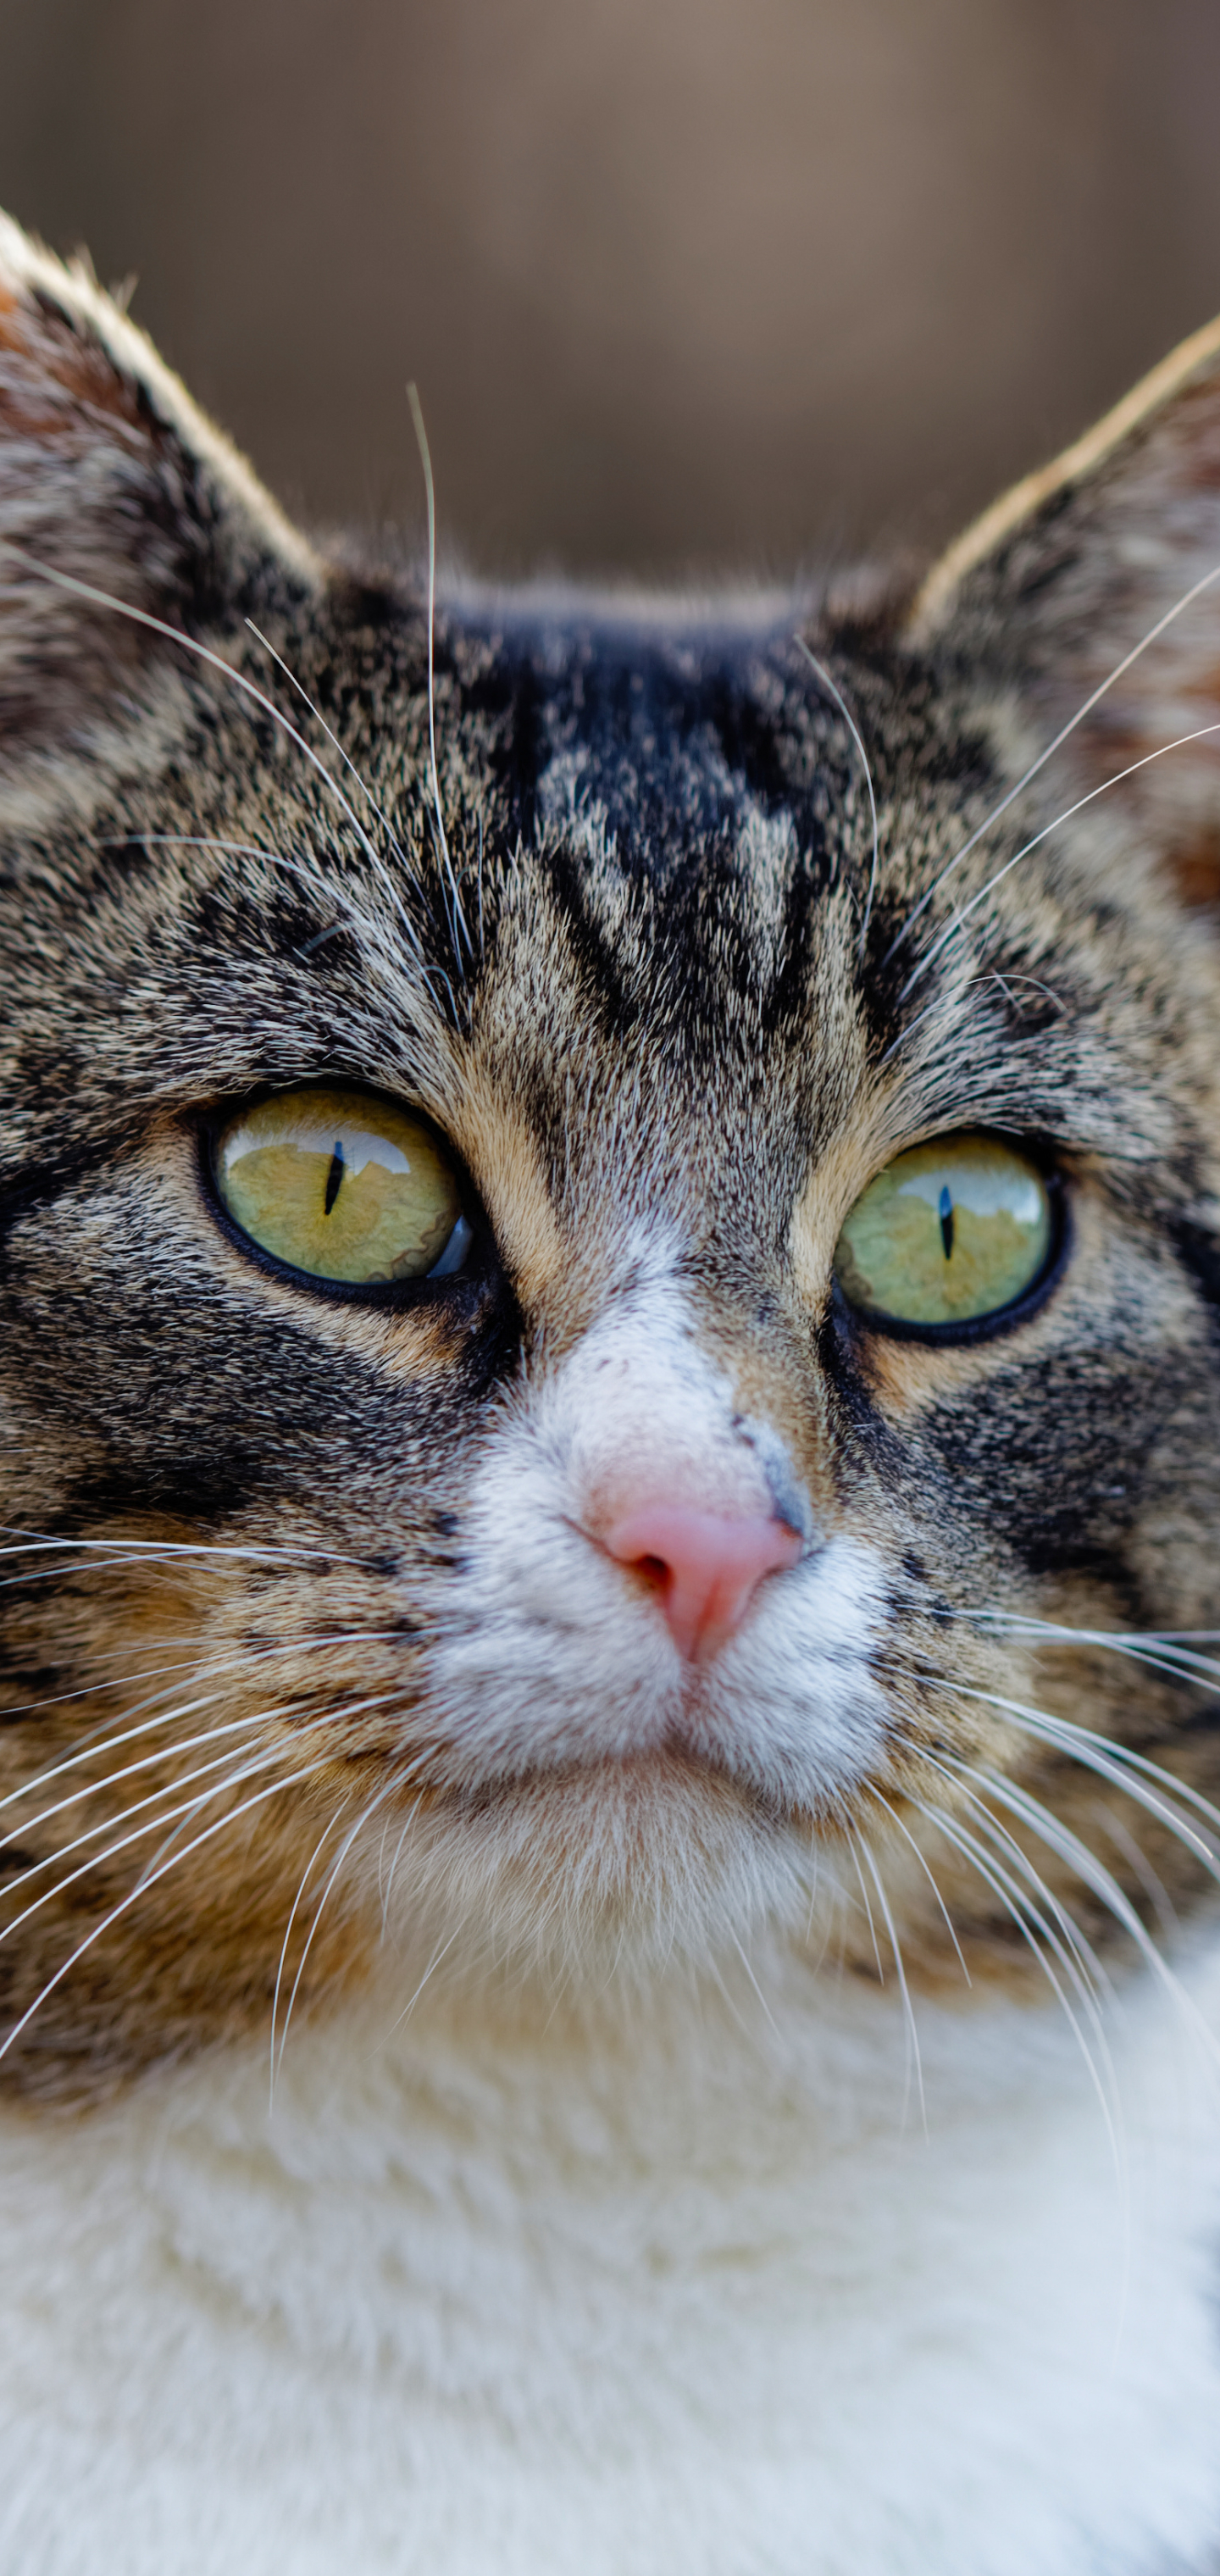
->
(908, 322), (1220, 907)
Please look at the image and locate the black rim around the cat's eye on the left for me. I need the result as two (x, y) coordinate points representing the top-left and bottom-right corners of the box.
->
(196, 1072), (499, 1313)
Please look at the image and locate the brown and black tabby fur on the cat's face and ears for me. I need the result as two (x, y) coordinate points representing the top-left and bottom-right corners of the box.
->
(0, 206), (1220, 2095)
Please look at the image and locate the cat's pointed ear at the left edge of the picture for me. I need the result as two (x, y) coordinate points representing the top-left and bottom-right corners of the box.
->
(0, 216), (319, 780)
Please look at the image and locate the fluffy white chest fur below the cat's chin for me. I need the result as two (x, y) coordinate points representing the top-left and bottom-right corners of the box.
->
(0, 1963), (1220, 2576)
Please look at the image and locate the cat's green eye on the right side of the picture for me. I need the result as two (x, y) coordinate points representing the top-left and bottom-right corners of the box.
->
(834, 1136), (1056, 1324)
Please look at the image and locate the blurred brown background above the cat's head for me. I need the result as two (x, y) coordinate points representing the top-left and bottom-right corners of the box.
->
(0, 0), (1220, 575)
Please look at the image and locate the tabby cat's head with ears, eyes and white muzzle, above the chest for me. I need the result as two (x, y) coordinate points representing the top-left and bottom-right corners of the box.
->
(0, 206), (1220, 2089)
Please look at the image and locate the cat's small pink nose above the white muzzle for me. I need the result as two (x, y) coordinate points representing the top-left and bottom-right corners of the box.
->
(602, 1502), (801, 1664)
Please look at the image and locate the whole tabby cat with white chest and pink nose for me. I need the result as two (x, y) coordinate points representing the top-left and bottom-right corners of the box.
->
(0, 206), (1220, 2576)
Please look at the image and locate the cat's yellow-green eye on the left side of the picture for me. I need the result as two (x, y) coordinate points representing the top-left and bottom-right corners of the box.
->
(216, 1087), (471, 1288)
